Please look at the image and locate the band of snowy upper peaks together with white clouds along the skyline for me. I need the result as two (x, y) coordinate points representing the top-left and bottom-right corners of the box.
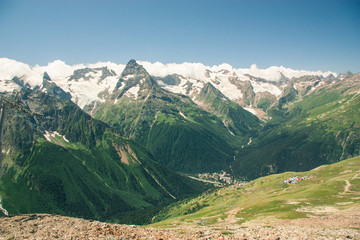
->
(0, 58), (338, 115)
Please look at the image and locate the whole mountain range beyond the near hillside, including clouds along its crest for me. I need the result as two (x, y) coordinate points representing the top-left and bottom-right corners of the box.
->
(0, 58), (360, 222)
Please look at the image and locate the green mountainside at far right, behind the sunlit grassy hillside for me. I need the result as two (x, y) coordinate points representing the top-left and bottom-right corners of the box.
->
(232, 75), (360, 179)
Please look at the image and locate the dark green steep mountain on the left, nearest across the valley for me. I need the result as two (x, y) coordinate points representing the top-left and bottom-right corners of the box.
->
(0, 92), (207, 223)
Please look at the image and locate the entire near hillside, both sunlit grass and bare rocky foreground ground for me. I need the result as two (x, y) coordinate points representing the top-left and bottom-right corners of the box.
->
(0, 157), (360, 239)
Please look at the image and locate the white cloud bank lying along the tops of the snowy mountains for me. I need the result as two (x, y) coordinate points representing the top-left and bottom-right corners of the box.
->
(0, 58), (338, 85)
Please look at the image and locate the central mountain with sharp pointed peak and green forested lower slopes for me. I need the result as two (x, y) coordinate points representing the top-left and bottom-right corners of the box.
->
(95, 60), (259, 173)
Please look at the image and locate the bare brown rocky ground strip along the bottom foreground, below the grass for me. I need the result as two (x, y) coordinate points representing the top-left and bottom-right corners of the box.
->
(0, 209), (360, 240)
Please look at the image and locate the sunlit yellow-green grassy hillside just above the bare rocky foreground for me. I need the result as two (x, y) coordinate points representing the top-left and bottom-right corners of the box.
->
(152, 157), (360, 230)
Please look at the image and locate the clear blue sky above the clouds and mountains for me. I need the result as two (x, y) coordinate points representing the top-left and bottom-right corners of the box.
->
(0, 0), (360, 73)
